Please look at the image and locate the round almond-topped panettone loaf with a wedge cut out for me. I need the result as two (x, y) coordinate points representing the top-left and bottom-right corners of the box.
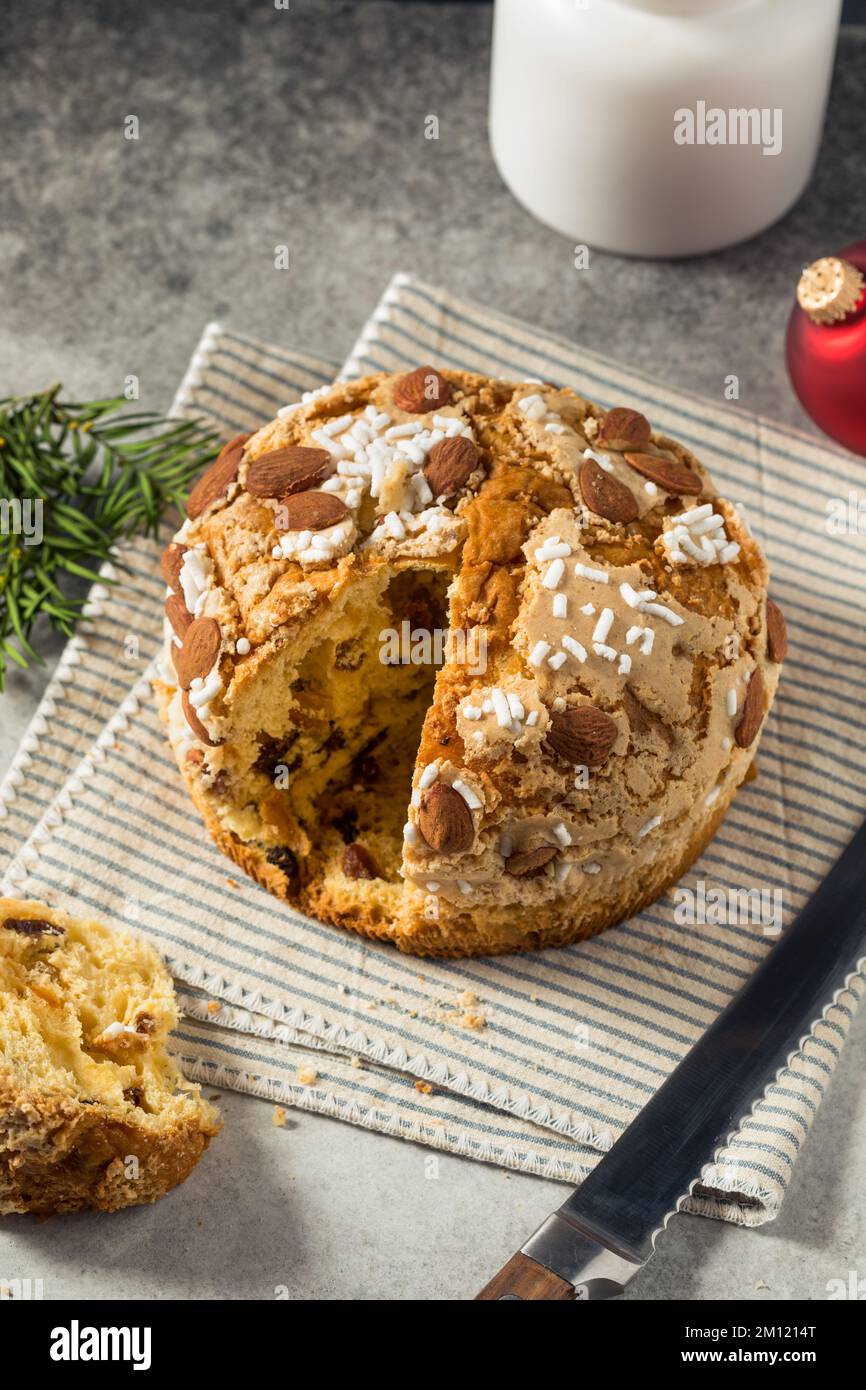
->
(157, 367), (785, 956)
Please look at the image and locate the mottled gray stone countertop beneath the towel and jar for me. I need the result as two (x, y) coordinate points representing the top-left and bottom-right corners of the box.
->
(0, 0), (866, 1300)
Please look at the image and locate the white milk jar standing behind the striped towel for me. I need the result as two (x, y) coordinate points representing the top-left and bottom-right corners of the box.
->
(491, 0), (841, 256)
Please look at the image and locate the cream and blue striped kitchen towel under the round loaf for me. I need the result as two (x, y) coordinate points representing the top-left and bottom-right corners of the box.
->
(0, 277), (866, 1225)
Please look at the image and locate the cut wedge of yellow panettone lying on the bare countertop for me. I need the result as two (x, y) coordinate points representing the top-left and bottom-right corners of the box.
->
(0, 898), (220, 1213)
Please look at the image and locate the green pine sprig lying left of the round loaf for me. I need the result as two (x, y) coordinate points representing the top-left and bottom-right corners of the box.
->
(0, 385), (220, 691)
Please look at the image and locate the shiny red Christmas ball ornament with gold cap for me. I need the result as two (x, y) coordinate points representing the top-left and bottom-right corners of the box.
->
(787, 242), (866, 455)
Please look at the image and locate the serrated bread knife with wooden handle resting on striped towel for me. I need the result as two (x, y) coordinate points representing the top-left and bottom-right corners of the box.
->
(477, 823), (866, 1301)
